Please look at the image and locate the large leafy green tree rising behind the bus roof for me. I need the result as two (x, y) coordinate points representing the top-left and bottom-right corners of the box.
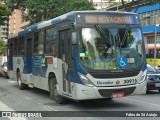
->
(6, 0), (94, 24)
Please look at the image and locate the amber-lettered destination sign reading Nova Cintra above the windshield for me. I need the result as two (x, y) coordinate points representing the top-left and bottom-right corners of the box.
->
(77, 14), (139, 24)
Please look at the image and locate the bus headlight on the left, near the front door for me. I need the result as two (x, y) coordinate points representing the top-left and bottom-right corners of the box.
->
(78, 73), (94, 87)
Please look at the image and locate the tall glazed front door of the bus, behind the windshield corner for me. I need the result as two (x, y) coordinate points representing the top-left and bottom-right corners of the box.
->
(60, 29), (71, 94)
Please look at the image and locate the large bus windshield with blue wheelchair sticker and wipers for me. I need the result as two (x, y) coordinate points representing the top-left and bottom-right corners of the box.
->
(78, 25), (144, 70)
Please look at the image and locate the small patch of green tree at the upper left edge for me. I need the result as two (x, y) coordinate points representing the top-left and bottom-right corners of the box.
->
(0, 4), (11, 25)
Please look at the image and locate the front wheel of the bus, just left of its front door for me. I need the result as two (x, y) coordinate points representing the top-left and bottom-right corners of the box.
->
(49, 78), (66, 104)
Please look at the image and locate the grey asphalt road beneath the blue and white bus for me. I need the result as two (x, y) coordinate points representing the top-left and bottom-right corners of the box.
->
(0, 78), (160, 120)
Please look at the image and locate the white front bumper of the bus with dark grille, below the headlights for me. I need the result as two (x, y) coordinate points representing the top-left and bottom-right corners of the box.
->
(75, 82), (146, 100)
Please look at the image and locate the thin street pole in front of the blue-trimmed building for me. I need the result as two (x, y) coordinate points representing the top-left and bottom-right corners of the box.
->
(154, 15), (157, 68)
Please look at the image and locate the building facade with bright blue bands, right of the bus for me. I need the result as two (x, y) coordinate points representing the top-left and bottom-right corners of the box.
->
(137, 4), (160, 44)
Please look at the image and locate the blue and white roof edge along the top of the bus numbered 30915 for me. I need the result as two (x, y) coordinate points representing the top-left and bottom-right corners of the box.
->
(8, 10), (137, 39)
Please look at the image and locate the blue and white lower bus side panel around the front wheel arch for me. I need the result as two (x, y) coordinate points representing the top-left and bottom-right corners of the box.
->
(33, 56), (75, 95)
